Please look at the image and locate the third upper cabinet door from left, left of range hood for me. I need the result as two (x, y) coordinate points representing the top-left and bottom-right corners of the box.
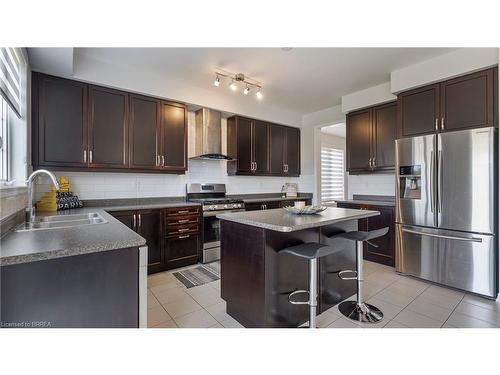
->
(129, 95), (161, 169)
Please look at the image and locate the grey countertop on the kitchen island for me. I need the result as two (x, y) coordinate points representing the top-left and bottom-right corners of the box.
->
(217, 207), (380, 232)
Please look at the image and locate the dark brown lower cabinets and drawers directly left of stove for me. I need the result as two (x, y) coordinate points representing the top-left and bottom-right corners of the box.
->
(110, 207), (200, 273)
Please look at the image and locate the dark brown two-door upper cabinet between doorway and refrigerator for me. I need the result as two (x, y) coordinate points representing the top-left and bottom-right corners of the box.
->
(346, 102), (397, 173)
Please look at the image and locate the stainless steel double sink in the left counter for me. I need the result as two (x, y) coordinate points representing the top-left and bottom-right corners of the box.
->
(16, 212), (107, 232)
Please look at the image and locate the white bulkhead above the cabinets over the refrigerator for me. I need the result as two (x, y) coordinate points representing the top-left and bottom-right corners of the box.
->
(391, 48), (499, 93)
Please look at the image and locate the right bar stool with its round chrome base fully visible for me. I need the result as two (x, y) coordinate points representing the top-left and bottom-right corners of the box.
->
(330, 227), (389, 323)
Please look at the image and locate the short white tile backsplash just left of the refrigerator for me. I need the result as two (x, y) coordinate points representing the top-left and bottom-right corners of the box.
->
(348, 174), (396, 199)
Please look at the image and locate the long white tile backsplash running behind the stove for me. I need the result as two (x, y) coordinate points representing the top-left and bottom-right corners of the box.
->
(37, 160), (314, 199)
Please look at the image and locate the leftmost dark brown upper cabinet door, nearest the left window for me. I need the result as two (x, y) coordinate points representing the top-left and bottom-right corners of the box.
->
(32, 73), (88, 168)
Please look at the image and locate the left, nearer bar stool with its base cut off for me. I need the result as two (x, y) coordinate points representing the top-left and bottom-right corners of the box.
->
(279, 242), (344, 328)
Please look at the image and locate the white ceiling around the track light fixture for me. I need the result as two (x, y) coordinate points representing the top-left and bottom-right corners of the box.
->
(75, 48), (453, 113)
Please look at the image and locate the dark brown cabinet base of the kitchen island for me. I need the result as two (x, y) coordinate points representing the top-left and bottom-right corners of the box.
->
(221, 220), (357, 328)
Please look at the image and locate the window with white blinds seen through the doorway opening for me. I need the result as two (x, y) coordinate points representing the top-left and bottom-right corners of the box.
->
(321, 143), (345, 204)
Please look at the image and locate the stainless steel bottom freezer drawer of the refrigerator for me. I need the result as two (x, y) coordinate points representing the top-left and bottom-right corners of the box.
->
(396, 224), (497, 297)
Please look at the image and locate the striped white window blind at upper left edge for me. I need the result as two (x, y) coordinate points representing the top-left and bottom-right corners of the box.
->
(0, 47), (25, 117)
